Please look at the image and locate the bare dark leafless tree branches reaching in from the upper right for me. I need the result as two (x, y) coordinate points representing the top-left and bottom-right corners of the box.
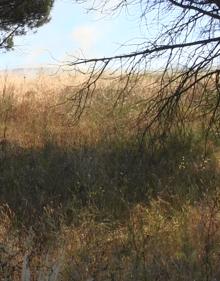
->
(62, 0), (220, 139)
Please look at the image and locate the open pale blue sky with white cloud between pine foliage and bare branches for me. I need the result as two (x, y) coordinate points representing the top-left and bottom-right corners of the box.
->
(0, 0), (146, 70)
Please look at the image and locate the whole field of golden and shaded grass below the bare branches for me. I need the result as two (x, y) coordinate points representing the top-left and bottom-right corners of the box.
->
(0, 73), (220, 281)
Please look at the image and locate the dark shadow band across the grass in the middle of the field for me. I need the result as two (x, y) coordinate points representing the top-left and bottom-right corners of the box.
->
(0, 132), (219, 229)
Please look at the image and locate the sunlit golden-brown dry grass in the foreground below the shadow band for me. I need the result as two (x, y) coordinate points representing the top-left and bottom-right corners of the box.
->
(1, 196), (220, 281)
